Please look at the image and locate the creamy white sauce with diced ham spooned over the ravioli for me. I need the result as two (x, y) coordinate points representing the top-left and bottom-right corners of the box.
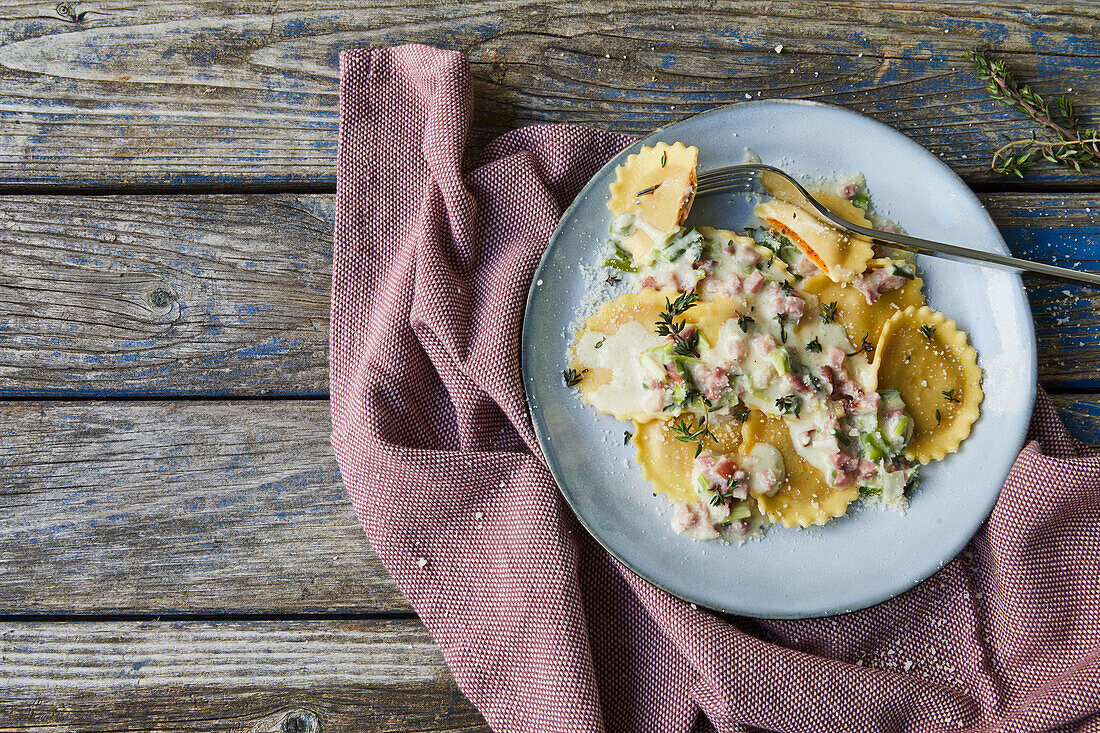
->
(575, 205), (914, 539)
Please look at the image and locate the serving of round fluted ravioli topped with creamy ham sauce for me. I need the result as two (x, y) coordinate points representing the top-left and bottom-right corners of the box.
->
(563, 143), (982, 541)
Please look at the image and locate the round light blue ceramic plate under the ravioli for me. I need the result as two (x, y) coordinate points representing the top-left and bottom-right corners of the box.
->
(523, 100), (1037, 619)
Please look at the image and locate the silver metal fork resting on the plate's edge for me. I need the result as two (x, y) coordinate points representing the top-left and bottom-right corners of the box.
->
(696, 163), (1100, 285)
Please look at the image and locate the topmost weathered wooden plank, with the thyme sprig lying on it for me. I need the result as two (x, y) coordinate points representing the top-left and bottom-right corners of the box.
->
(0, 0), (1100, 186)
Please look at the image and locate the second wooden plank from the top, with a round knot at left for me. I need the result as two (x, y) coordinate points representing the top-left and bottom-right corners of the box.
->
(0, 188), (1100, 397)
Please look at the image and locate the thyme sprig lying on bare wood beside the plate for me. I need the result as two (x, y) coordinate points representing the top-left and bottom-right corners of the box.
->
(965, 50), (1100, 178)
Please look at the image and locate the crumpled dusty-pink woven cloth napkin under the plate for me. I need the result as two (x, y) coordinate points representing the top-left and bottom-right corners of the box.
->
(331, 46), (1100, 733)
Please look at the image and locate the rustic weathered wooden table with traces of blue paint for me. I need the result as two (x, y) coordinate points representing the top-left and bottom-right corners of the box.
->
(0, 0), (1100, 731)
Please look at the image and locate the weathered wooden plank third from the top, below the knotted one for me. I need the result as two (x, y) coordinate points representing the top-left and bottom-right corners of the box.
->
(0, 395), (1100, 611)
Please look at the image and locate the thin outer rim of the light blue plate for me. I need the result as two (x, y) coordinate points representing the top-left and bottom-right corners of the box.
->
(519, 98), (1038, 620)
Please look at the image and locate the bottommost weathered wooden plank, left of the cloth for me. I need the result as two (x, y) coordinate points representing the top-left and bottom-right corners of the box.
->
(0, 621), (488, 733)
